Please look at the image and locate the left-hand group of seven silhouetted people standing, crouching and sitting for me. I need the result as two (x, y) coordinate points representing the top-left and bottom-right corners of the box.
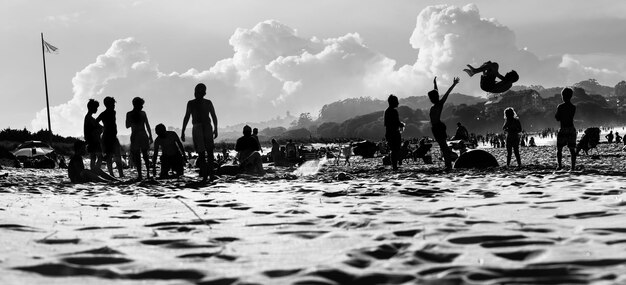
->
(68, 83), (263, 183)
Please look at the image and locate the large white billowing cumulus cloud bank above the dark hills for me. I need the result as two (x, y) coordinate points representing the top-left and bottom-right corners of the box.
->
(32, 5), (624, 135)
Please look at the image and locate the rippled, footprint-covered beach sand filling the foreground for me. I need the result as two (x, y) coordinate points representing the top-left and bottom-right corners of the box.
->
(0, 144), (626, 284)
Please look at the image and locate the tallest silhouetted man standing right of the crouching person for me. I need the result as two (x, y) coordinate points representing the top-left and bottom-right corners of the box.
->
(180, 83), (217, 183)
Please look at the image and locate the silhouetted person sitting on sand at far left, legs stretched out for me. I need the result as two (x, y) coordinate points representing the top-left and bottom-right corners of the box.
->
(67, 140), (119, 184)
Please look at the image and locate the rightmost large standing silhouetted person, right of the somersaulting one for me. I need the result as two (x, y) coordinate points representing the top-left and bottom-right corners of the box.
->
(554, 87), (577, 170)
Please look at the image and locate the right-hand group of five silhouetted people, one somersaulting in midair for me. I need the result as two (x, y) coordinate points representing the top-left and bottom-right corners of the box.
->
(384, 61), (577, 170)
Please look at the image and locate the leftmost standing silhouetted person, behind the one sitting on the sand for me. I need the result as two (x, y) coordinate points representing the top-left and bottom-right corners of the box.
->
(83, 99), (102, 171)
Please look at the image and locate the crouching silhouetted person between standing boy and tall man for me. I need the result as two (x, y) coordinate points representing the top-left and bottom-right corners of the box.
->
(152, 124), (187, 178)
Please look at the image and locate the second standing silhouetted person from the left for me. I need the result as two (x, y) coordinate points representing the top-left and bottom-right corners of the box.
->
(96, 97), (124, 178)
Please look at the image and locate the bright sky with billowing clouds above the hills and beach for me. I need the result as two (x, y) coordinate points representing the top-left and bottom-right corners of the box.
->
(0, 0), (626, 136)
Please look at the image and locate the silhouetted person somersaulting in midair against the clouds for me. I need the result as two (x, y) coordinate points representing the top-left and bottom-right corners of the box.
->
(463, 61), (519, 93)
